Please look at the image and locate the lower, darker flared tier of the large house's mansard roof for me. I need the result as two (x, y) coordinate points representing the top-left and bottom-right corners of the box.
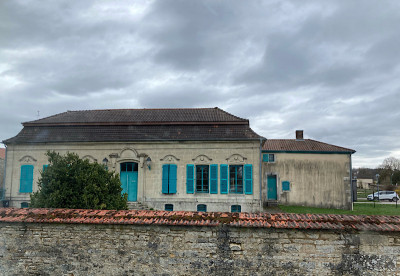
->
(4, 124), (262, 144)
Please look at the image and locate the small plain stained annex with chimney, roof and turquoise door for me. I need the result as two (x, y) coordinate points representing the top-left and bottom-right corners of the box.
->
(262, 130), (355, 209)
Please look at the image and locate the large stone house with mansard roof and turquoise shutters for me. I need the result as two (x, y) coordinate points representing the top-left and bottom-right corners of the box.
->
(3, 108), (265, 212)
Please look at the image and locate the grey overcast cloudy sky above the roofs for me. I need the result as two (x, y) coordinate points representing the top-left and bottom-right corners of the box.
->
(0, 0), (400, 167)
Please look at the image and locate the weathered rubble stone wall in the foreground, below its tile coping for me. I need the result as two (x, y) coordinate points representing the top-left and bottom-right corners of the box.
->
(0, 222), (400, 275)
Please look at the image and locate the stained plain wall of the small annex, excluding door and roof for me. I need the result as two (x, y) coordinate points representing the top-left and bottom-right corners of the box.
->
(262, 153), (352, 209)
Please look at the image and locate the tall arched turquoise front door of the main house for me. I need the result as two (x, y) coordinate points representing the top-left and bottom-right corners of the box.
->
(120, 162), (138, 201)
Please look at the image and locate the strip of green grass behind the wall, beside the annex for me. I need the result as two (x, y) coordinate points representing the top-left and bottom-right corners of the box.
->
(279, 203), (400, 216)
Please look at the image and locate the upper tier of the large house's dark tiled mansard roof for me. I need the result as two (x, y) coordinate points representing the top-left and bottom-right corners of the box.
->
(23, 107), (248, 125)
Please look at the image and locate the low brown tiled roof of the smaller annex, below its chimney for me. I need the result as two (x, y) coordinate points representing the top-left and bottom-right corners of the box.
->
(263, 139), (356, 153)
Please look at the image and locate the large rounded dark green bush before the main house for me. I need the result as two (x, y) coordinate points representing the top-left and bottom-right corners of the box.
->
(31, 151), (127, 210)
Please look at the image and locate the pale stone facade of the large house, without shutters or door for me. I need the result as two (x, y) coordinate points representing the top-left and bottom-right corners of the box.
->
(6, 140), (260, 212)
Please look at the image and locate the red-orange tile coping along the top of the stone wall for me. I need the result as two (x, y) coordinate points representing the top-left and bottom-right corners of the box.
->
(0, 208), (400, 232)
